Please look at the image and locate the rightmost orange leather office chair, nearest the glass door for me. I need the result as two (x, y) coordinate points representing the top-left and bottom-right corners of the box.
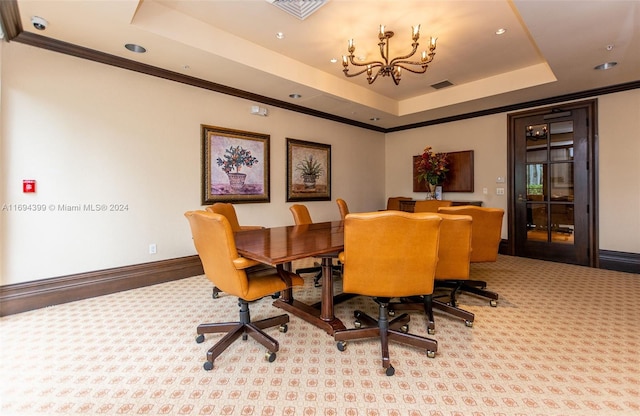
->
(438, 205), (504, 306)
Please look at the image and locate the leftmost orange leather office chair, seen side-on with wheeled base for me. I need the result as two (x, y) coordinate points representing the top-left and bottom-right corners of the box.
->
(184, 211), (303, 370)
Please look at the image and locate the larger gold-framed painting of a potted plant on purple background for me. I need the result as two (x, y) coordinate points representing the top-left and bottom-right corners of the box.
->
(200, 124), (270, 205)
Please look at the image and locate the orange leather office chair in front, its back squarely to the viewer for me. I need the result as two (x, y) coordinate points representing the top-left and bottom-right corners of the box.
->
(334, 211), (442, 376)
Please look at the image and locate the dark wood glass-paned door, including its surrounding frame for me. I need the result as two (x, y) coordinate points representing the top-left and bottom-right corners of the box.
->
(509, 101), (597, 267)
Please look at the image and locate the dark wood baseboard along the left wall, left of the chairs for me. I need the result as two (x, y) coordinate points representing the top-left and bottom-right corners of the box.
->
(0, 256), (204, 316)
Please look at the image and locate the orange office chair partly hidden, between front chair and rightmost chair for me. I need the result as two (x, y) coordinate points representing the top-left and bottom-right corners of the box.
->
(389, 214), (475, 334)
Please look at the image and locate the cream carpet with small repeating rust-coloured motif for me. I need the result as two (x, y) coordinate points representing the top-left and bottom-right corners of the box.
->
(0, 256), (640, 416)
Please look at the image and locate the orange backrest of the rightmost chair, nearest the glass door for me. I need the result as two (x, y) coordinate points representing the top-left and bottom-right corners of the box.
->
(438, 205), (504, 263)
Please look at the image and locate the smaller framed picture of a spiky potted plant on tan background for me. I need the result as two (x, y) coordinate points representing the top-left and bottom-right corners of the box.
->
(287, 138), (331, 202)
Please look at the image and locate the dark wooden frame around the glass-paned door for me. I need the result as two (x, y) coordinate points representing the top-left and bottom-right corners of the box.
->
(506, 99), (600, 267)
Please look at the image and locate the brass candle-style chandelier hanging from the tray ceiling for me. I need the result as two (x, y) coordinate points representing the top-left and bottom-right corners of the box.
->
(342, 25), (437, 85)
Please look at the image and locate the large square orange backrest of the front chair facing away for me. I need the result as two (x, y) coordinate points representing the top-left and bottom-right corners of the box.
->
(340, 211), (442, 297)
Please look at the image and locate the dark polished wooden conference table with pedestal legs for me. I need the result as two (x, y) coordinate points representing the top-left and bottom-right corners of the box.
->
(235, 221), (345, 335)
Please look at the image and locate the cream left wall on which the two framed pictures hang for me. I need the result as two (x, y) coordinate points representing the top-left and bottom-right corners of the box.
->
(0, 43), (385, 285)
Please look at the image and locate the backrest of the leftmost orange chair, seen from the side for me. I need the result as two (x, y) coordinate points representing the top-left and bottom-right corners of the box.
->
(184, 211), (254, 300)
